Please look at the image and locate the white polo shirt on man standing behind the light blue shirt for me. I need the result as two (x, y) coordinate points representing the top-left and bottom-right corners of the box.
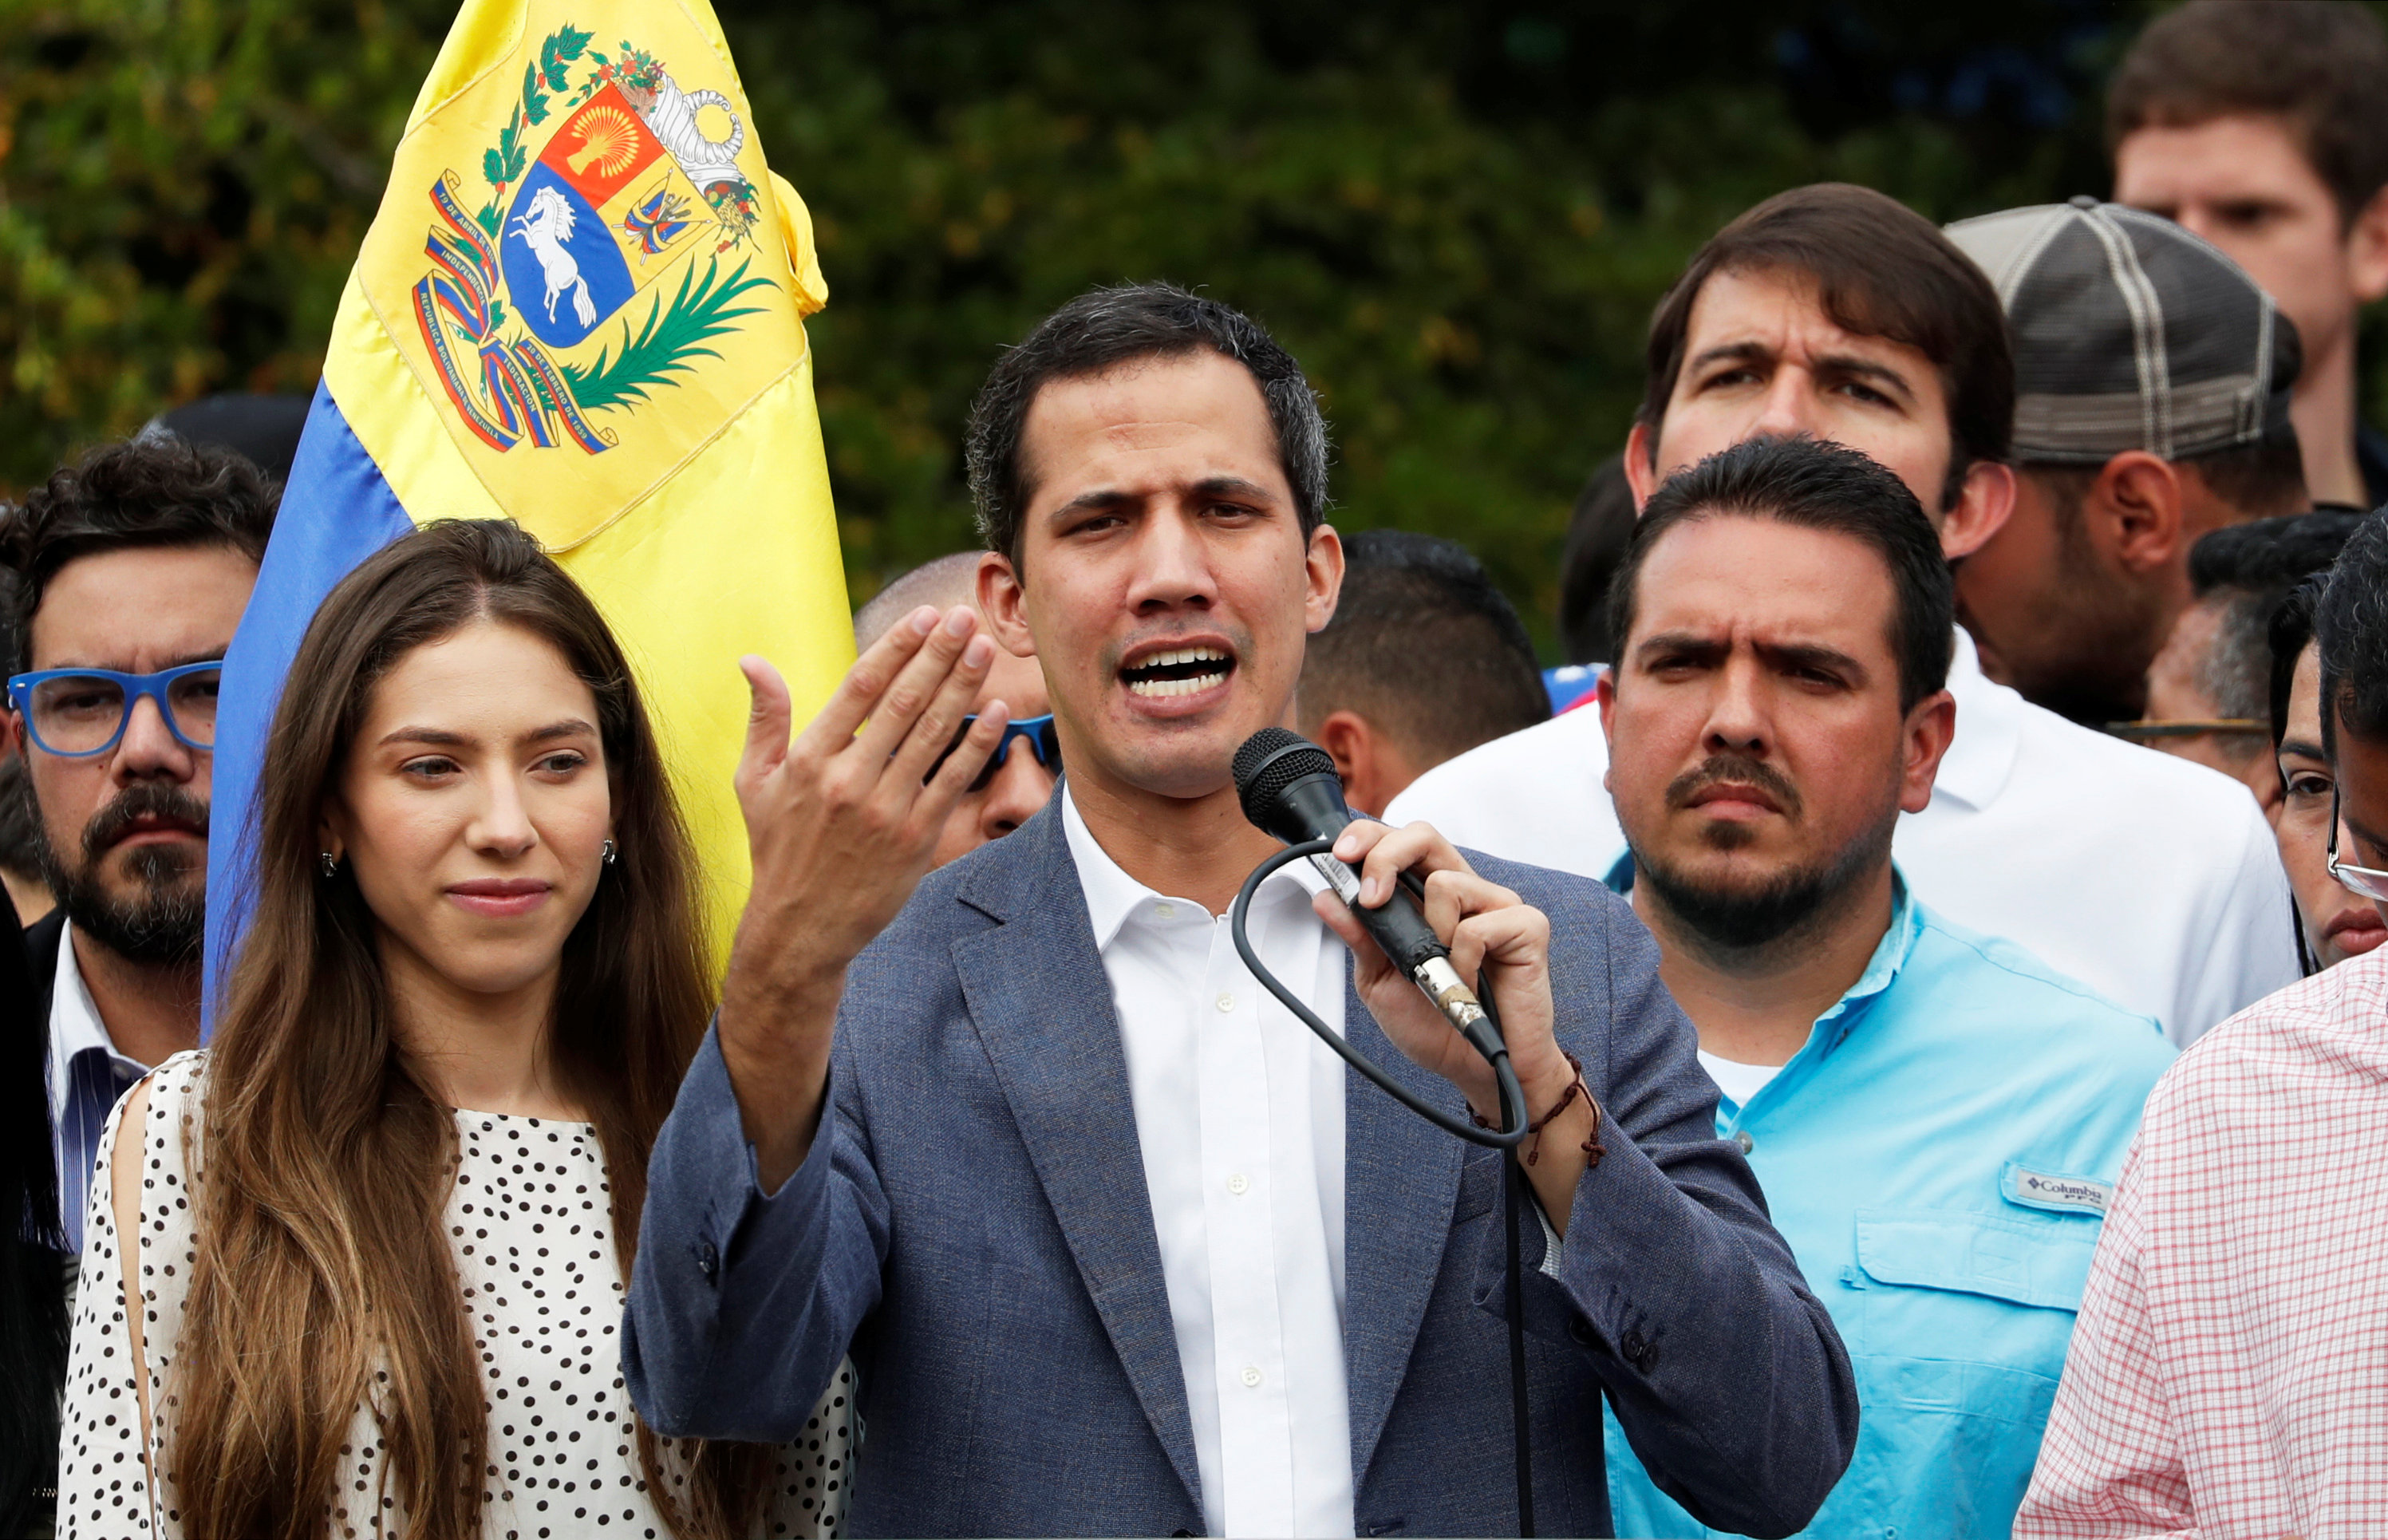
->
(1385, 630), (2297, 1046)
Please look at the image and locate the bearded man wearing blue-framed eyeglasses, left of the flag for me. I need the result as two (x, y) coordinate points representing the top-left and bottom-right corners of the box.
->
(0, 435), (279, 1251)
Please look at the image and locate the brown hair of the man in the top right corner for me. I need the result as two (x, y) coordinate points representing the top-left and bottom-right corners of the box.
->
(2106, 0), (2388, 224)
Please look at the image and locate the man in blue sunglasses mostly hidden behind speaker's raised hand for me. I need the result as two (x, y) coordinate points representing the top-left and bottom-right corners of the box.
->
(855, 551), (1060, 867)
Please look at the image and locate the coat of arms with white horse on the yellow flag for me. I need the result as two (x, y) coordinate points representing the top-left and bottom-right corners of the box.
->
(358, 10), (812, 549)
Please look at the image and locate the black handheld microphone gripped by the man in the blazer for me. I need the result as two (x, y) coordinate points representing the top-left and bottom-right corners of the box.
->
(1234, 729), (1502, 1058)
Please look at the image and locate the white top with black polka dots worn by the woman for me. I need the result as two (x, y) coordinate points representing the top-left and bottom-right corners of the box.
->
(57, 1053), (859, 1540)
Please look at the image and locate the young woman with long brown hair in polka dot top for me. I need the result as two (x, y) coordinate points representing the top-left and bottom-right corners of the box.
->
(57, 523), (853, 1540)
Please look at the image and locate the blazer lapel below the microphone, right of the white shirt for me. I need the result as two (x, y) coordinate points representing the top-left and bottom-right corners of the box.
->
(1344, 959), (1466, 1485)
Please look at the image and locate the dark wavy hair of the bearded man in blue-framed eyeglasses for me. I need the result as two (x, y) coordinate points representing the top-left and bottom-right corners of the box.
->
(0, 435), (282, 673)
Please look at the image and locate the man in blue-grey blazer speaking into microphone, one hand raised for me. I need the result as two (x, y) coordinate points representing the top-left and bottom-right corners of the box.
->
(623, 286), (1856, 1535)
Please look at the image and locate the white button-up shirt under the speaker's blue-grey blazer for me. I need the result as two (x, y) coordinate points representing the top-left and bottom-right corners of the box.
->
(1063, 790), (1352, 1535)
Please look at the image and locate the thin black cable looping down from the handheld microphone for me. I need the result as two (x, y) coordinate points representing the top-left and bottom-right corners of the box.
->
(1227, 840), (1533, 1538)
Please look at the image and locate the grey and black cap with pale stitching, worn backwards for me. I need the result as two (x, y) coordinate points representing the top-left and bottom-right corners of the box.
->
(1948, 198), (2302, 463)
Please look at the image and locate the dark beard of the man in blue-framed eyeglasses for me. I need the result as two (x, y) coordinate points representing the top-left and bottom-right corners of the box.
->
(26, 780), (207, 967)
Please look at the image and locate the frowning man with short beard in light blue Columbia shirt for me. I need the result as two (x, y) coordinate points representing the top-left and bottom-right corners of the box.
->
(1597, 440), (2173, 1540)
